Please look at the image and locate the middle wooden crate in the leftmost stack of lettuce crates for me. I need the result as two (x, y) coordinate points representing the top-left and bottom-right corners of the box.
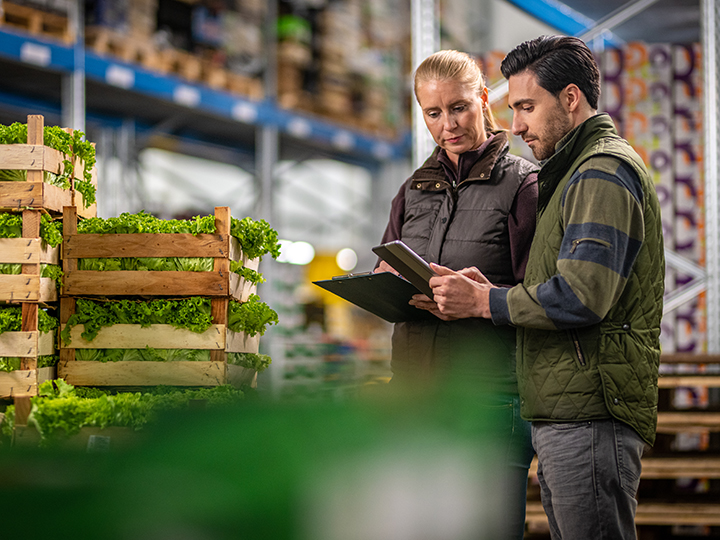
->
(0, 208), (60, 304)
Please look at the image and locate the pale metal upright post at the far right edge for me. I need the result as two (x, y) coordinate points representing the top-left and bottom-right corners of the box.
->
(701, 0), (720, 354)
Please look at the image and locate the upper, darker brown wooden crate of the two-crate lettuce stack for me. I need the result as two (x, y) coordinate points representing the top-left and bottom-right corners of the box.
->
(61, 206), (259, 302)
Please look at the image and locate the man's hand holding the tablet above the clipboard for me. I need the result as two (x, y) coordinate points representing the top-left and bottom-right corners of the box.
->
(410, 263), (494, 320)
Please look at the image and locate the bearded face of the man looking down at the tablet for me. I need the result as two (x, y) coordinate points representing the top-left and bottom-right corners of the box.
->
(508, 70), (574, 161)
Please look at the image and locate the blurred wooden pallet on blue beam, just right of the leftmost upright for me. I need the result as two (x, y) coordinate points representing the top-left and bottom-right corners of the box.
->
(85, 26), (161, 70)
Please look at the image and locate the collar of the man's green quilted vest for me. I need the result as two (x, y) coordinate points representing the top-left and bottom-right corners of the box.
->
(538, 113), (619, 211)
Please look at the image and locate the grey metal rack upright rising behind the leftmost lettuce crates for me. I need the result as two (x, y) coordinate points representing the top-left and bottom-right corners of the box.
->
(62, 0), (85, 132)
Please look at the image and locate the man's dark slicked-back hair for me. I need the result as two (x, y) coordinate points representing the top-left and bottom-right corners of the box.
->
(500, 36), (600, 109)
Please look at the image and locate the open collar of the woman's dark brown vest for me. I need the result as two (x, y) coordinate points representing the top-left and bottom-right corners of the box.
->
(410, 130), (510, 191)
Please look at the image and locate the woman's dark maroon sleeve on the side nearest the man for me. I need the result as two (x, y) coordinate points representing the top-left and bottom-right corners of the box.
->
(508, 173), (538, 283)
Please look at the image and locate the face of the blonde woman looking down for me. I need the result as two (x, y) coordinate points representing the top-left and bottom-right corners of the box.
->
(417, 79), (487, 165)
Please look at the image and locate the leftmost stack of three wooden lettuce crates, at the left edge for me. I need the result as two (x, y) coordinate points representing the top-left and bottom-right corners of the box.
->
(0, 115), (95, 399)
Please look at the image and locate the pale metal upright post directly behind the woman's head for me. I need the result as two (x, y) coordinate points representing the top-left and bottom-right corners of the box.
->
(410, 0), (440, 169)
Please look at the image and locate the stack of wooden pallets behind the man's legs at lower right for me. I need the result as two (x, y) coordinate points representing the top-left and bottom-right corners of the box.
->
(526, 354), (720, 540)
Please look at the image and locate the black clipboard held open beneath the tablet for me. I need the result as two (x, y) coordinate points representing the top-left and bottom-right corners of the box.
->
(313, 272), (435, 323)
